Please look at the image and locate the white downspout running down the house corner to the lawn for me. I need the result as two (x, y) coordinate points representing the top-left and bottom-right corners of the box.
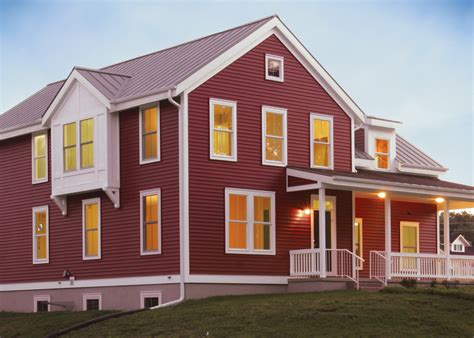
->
(150, 89), (187, 310)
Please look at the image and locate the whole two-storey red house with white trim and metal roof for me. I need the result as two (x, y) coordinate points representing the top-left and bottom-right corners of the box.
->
(0, 16), (474, 311)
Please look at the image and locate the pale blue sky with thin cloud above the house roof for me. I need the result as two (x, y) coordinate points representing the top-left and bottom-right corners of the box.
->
(0, 0), (474, 185)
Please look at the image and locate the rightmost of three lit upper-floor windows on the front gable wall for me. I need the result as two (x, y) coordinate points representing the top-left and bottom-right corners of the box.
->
(310, 114), (333, 169)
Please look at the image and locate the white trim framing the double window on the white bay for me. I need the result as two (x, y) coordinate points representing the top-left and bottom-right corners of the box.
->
(61, 115), (98, 176)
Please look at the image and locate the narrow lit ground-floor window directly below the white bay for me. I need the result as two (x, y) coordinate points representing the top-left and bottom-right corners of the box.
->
(82, 198), (101, 260)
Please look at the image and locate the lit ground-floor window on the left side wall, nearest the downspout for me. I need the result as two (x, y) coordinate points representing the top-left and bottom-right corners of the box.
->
(140, 189), (161, 255)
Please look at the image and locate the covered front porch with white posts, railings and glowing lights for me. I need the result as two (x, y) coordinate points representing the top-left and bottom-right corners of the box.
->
(287, 168), (474, 287)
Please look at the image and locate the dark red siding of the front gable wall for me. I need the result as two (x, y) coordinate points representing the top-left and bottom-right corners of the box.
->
(189, 36), (351, 275)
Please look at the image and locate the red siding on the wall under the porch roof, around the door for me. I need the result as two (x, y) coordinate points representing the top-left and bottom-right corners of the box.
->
(355, 198), (437, 277)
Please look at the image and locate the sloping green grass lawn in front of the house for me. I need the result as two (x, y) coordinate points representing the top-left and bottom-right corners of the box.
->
(0, 289), (474, 337)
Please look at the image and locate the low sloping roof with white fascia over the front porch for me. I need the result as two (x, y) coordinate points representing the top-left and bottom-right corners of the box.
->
(286, 167), (474, 202)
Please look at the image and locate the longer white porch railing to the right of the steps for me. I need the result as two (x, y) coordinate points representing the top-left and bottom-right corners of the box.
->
(370, 251), (474, 283)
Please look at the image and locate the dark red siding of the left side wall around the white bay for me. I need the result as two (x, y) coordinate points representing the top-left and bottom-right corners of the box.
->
(0, 99), (179, 283)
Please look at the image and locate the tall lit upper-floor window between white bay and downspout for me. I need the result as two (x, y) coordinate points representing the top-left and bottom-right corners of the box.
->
(140, 106), (160, 164)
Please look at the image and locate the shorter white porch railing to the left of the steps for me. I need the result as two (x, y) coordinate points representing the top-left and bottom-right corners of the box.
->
(290, 249), (364, 287)
